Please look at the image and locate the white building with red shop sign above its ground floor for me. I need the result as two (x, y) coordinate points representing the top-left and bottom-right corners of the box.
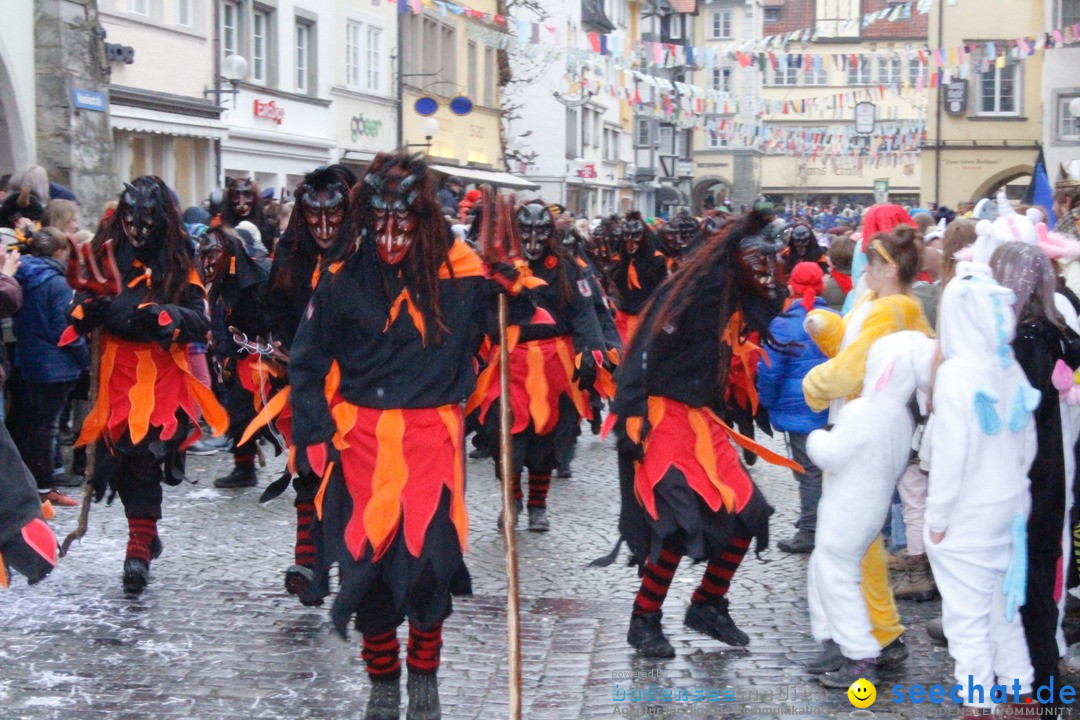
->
(216, 0), (336, 196)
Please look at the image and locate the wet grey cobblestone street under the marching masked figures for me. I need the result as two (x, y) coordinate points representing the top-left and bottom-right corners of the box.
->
(0, 434), (951, 720)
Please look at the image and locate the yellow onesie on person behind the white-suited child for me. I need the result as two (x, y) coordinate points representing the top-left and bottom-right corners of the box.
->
(802, 293), (933, 648)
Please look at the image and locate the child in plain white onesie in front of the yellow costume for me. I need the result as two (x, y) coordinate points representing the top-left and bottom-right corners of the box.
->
(807, 330), (935, 687)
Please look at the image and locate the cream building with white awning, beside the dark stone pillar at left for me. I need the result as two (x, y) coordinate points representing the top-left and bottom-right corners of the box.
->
(100, 0), (226, 207)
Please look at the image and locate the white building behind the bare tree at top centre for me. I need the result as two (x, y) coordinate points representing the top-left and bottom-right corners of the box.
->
(503, 0), (635, 217)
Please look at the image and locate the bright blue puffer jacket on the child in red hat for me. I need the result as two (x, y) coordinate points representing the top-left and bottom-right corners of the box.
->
(757, 298), (834, 433)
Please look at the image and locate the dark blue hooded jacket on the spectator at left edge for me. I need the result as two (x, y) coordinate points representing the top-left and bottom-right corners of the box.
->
(12, 257), (90, 382)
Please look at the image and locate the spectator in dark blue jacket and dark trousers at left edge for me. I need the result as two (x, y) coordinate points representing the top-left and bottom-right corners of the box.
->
(14, 228), (89, 507)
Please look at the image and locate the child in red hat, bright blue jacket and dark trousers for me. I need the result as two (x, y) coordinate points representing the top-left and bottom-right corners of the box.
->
(757, 262), (832, 553)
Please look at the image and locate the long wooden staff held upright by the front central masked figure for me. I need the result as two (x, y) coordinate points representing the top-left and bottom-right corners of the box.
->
(499, 295), (522, 720)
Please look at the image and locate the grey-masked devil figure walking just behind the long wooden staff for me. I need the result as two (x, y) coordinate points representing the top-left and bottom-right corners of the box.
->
(465, 200), (605, 532)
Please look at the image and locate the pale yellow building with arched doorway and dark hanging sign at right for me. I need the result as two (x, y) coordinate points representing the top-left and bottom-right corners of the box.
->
(921, 0), (1041, 206)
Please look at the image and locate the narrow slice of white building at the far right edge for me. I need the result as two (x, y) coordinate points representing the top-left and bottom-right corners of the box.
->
(1042, 0), (1080, 182)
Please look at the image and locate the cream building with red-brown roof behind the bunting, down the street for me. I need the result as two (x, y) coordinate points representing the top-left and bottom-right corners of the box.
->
(693, 0), (929, 212)
